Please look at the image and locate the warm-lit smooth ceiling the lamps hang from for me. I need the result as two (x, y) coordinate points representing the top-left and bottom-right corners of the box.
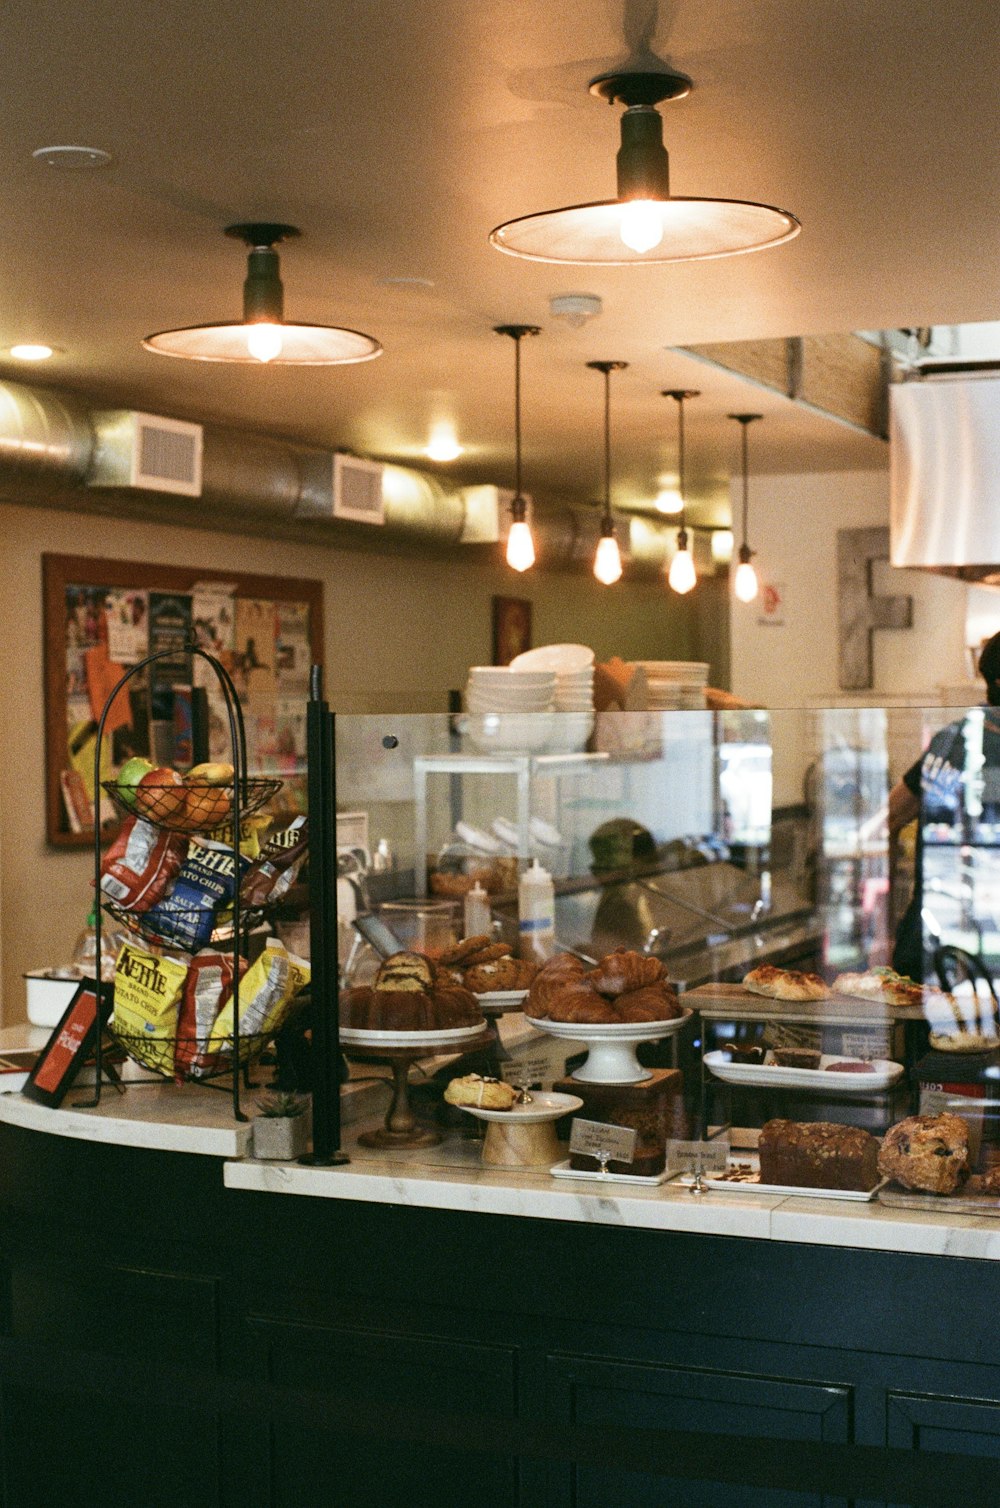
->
(0, 0), (1000, 520)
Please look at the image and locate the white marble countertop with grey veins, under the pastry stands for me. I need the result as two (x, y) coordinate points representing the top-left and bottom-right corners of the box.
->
(7, 1022), (1000, 1261)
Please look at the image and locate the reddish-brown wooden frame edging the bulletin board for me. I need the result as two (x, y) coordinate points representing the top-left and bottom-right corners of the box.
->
(42, 555), (323, 849)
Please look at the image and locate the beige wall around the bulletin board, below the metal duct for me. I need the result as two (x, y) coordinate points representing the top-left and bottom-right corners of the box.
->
(0, 507), (698, 1024)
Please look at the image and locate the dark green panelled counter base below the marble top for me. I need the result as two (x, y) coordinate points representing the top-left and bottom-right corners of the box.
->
(0, 1125), (1000, 1508)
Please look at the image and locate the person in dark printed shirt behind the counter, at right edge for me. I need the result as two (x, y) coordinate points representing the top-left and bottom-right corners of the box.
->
(888, 633), (1000, 980)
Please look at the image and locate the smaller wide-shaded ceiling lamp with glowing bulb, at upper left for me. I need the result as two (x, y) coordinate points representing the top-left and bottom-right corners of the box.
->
(142, 223), (382, 366)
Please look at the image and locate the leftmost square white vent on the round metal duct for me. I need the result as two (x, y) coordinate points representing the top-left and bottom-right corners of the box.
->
(87, 409), (202, 498)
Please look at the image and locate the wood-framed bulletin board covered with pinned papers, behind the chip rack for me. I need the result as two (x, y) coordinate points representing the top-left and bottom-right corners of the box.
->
(42, 555), (323, 847)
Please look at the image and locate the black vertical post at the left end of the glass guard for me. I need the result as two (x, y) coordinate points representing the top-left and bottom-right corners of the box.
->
(300, 665), (348, 1167)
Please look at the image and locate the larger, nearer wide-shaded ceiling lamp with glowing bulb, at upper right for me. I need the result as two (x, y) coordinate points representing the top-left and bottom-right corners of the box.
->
(490, 69), (802, 267)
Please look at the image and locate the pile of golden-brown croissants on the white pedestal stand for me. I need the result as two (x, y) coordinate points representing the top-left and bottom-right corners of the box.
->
(523, 949), (683, 1025)
